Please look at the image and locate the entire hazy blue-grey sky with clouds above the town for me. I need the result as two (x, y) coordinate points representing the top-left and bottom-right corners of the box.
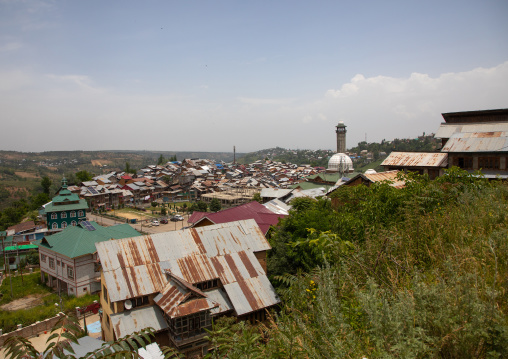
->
(0, 0), (508, 152)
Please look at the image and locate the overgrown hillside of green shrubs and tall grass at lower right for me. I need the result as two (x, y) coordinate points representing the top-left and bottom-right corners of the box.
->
(214, 168), (508, 358)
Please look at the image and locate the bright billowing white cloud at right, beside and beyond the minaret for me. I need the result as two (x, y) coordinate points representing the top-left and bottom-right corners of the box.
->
(313, 62), (508, 146)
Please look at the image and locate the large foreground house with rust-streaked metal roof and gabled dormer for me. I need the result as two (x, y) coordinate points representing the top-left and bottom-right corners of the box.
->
(96, 219), (280, 357)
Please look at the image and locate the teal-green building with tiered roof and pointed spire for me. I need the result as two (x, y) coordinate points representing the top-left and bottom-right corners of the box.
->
(44, 177), (88, 231)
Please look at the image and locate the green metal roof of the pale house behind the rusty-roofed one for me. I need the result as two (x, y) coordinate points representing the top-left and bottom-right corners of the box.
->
(39, 222), (141, 258)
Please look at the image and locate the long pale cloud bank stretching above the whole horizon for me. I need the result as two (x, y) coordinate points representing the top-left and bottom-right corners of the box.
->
(0, 62), (508, 152)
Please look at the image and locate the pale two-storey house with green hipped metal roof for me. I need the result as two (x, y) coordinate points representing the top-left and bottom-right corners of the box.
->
(38, 221), (141, 297)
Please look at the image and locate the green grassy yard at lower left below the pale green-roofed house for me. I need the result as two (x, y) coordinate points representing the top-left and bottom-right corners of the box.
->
(0, 272), (99, 332)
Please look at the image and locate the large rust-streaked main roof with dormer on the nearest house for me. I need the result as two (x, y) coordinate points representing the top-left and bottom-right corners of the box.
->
(97, 219), (280, 316)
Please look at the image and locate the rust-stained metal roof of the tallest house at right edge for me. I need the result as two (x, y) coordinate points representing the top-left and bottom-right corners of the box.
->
(441, 131), (508, 152)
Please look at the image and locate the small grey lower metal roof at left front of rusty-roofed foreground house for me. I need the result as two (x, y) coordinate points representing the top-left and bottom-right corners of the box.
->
(110, 305), (168, 338)
